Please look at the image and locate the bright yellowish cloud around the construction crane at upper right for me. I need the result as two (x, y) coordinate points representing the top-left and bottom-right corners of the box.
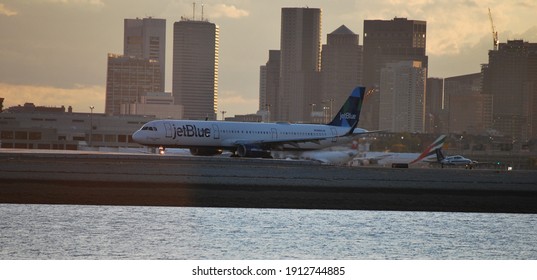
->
(355, 0), (537, 56)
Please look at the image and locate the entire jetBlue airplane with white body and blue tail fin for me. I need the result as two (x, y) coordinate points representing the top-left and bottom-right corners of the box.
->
(132, 87), (367, 157)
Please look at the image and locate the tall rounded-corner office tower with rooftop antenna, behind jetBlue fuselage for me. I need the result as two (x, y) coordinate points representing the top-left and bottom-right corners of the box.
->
(172, 18), (219, 120)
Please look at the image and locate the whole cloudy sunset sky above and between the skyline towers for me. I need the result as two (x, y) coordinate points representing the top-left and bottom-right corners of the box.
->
(0, 0), (537, 117)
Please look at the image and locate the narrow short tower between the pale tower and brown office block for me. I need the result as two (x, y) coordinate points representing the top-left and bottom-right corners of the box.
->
(425, 78), (448, 134)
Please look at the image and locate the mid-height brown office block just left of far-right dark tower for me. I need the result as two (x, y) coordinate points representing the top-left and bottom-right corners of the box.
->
(444, 73), (492, 135)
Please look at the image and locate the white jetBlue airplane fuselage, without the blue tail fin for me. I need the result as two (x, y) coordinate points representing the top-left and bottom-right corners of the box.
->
(133, 120), (363, 151)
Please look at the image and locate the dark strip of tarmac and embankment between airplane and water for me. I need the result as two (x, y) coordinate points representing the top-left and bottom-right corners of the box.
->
(0, 149), (537, 213)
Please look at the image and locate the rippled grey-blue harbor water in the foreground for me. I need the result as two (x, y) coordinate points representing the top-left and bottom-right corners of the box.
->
(0, 204), (537, 260)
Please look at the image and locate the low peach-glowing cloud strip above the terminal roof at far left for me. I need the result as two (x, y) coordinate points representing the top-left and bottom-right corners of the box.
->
(0, 83), (106, 113)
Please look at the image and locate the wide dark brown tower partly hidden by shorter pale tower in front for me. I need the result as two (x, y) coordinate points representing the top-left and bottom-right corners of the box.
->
(360, 18), (428, 129)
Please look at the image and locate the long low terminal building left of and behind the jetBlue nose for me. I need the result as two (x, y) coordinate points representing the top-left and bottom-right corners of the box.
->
(0, 103), (155, 151)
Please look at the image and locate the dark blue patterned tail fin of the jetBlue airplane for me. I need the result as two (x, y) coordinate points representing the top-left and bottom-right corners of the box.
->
(328, 86), (365, 133)
